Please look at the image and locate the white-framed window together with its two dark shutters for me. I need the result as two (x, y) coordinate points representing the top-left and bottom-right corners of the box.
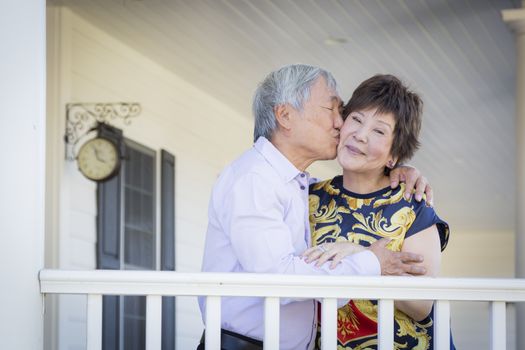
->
(97, 129), (175, 350)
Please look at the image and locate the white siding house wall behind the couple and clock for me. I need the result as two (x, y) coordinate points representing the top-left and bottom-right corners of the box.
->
(46, 5), (514, 349)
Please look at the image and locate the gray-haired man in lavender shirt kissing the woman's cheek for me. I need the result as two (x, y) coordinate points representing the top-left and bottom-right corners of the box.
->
(199, 65), (430, 350)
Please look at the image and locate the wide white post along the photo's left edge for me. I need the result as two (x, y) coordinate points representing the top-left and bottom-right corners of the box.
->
(0, 0), (46, 350)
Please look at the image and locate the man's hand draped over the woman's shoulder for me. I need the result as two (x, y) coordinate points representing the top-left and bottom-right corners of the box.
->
(390, 165), (434, 207)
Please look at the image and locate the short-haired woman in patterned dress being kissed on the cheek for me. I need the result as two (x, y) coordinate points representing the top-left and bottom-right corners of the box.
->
(305, 75), (454, 349)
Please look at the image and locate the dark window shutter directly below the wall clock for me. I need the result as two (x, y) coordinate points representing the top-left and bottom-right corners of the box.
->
(97, 127), (122, 350)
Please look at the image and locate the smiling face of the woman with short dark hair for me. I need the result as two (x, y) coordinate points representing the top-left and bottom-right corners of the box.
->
(337, 108), (396, 172)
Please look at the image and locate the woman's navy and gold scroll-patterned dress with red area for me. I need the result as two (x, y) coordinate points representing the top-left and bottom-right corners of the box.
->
(309, 176), (454, 350)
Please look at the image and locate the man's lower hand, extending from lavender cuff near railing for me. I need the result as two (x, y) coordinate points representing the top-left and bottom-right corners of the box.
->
(368, 238), (426, 276)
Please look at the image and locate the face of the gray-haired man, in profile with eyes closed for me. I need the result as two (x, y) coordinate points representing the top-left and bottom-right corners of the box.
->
(293, 77), (343, 162)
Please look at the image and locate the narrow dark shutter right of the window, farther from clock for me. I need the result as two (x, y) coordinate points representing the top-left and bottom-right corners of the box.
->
(160, 150), (175, 350)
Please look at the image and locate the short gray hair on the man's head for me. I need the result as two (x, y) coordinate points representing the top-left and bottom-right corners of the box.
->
(252, 64), (337, 141)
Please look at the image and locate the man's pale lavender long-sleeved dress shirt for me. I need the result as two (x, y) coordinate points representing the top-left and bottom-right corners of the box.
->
(199, 137), (380, 350)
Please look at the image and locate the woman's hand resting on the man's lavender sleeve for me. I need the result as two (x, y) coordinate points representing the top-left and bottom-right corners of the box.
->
(302, 242), (366, 269)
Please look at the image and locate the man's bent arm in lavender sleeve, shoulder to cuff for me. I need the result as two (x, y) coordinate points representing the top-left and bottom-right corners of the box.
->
(223, 174), (380, 275)
